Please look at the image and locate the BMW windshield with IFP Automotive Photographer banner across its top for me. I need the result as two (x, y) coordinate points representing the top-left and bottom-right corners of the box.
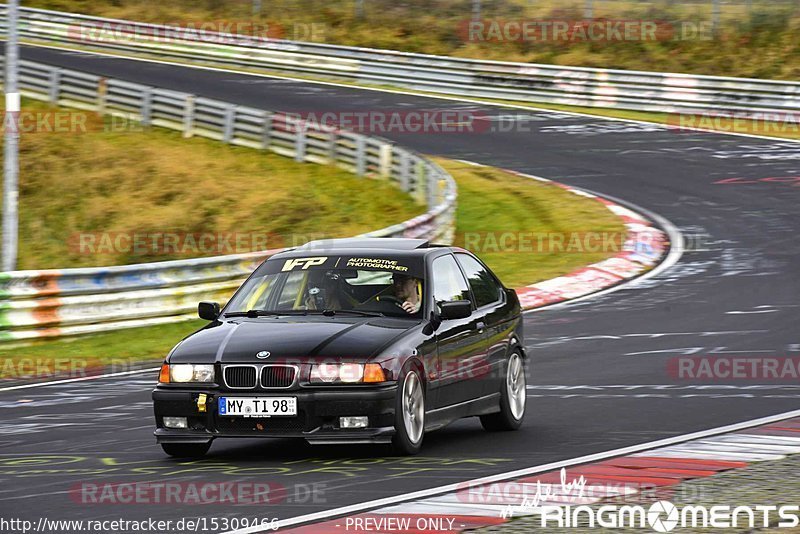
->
(225, 256), (425, 318)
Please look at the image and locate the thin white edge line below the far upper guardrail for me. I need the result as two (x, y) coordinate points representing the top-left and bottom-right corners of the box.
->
(22, 42), (800, 143)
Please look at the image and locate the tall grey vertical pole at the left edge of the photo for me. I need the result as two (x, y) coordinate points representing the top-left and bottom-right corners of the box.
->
(2, 0), (20, 271)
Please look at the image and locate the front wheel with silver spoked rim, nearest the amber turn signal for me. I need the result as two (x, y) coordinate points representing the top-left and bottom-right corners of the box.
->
(392, 368), (425, 456)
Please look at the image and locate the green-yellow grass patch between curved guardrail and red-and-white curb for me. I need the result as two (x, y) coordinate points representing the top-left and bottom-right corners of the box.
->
(437, 159), (625, 287)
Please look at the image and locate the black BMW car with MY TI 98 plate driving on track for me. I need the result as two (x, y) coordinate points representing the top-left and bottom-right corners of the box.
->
(153, 238), (526, 457)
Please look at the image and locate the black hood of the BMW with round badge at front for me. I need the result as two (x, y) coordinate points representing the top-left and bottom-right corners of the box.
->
(169, 316), (420, 363)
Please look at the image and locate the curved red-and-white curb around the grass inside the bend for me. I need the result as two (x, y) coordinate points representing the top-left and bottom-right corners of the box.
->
(506, 171), (682, 310)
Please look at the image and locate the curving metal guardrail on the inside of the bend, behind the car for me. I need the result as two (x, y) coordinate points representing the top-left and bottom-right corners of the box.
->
(0, 61), (456, 341)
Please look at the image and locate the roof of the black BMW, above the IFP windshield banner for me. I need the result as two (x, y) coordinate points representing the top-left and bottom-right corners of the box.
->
(275, 237), (450, 257)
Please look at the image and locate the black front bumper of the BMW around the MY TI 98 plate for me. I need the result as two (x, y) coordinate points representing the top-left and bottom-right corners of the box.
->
(153, 384), (397, 444)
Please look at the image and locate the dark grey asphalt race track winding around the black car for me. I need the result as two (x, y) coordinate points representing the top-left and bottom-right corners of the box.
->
(0, 48), (800, 532)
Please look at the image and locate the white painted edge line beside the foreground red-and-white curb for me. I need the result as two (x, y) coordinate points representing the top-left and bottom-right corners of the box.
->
(222, 410), (800, 534)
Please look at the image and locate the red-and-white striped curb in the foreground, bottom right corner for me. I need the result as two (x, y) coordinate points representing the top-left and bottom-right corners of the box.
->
(262, 411), (800, 534)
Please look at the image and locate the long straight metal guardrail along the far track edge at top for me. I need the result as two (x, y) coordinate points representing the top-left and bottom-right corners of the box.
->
(0, 4), (800, 115)
